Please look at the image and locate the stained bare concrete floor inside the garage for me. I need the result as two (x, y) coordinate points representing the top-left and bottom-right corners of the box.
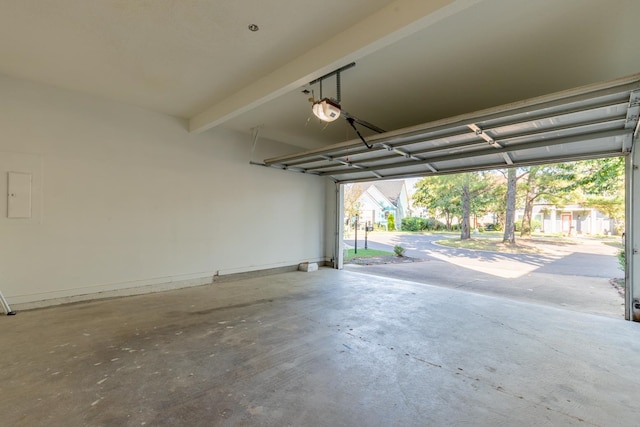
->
(0, 269), (640, 426)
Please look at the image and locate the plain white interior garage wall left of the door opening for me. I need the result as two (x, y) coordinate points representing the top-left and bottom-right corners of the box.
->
(0, 76), (331, 304)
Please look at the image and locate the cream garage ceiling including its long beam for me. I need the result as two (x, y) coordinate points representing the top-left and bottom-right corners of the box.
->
(0, 0), (640, 158)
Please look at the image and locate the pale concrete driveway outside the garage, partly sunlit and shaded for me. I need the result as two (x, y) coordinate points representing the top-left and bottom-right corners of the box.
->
(345, 232), (624, 318)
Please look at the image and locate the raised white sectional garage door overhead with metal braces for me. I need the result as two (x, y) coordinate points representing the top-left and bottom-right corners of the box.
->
(264, 74), (640, 182)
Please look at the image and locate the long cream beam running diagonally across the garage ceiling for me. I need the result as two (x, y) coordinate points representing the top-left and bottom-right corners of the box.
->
(189, 0), (482, 133)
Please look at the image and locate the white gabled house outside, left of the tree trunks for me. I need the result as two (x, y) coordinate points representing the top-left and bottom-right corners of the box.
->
(358, 180), (410, 229)
